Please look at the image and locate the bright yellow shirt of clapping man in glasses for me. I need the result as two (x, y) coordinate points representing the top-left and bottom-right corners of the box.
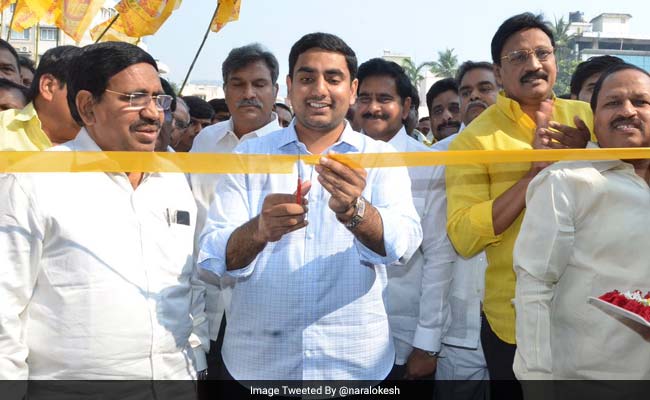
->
(446, 92), (593, 344)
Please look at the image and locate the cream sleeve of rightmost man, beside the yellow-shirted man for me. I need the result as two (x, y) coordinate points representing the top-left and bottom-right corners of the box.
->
(513, 171), (574, 380)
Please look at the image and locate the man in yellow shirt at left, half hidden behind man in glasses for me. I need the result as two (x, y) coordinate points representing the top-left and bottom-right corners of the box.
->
(0, 46), (80, 151)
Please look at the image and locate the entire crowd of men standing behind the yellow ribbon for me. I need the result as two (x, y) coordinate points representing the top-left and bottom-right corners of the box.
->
(0, 13), (650, 399)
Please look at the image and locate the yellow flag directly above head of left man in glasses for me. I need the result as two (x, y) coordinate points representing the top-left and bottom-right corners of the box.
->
(90, 0), (181, 41)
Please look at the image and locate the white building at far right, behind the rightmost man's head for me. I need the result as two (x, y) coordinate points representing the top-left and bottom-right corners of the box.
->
(567, 11), (650, 71)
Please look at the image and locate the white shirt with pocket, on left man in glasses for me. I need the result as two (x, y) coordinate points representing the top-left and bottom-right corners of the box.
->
(0, 129), (207, 380)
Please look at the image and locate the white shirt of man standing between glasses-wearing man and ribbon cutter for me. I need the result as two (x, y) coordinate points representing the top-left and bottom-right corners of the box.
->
(190, 113), (282, 340)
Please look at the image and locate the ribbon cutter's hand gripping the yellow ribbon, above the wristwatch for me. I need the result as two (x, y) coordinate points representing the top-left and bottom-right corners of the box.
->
(316, 153), (368, 222)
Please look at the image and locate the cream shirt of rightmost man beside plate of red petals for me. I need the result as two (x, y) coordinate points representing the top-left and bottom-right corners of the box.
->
(514, 155), (650, 380)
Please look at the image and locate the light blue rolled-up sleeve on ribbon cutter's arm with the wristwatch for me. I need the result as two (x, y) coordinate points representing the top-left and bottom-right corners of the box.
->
(355, 162), (422, 265)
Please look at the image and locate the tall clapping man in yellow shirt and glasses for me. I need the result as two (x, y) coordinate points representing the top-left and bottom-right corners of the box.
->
(446, 13), (593, 399)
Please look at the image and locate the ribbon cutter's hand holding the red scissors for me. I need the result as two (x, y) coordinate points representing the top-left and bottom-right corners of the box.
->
(253, 181), (311, 243)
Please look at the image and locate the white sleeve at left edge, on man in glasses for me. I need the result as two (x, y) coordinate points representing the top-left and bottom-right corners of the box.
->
(0, 175), (44, 380)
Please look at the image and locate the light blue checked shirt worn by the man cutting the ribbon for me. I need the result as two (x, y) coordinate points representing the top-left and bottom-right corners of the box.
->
(198, 124), (422, 380)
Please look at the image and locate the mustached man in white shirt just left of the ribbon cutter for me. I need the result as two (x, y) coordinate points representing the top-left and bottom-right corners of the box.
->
(190, 43), (281, 377)
